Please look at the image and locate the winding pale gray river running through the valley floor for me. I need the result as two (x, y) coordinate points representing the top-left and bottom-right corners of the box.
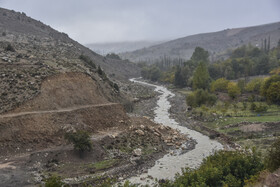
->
(128, 79), (223, 185)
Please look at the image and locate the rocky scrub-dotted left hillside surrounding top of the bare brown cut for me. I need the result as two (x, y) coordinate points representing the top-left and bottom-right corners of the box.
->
(0, 8), (139, 113)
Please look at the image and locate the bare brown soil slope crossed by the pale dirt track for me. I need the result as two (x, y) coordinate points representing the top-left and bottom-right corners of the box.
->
(0, 73), (129, 154)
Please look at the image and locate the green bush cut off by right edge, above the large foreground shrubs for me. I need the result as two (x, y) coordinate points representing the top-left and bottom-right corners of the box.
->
(265, 138), (280, 171)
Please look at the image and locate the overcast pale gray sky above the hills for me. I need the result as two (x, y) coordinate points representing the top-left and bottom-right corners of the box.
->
(0, 0), (280, 44)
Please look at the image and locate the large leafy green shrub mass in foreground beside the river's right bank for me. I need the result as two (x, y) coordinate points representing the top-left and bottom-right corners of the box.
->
(160, 151), (263, 187)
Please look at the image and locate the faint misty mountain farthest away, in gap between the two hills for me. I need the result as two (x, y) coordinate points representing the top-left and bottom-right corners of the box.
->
(86, 41), (165, 55)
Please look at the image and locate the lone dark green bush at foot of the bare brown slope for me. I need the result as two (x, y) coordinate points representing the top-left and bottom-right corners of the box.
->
(64, 130), (92, 153)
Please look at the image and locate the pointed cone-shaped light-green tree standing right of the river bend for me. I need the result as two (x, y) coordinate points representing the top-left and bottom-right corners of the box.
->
(193, 62), (210, 90)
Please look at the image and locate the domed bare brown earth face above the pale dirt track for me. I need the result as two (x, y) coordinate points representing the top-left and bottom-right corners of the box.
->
(10, 73), (108, 112)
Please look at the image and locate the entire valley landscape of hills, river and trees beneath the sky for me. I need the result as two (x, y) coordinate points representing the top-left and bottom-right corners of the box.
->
(0, 4), (280, 187)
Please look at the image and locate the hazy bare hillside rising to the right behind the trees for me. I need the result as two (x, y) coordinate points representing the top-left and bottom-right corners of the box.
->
(120, 22), (280, 63)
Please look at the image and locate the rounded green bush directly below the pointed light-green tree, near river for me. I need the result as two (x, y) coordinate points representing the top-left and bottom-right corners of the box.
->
(186, 89), (217, 107)
